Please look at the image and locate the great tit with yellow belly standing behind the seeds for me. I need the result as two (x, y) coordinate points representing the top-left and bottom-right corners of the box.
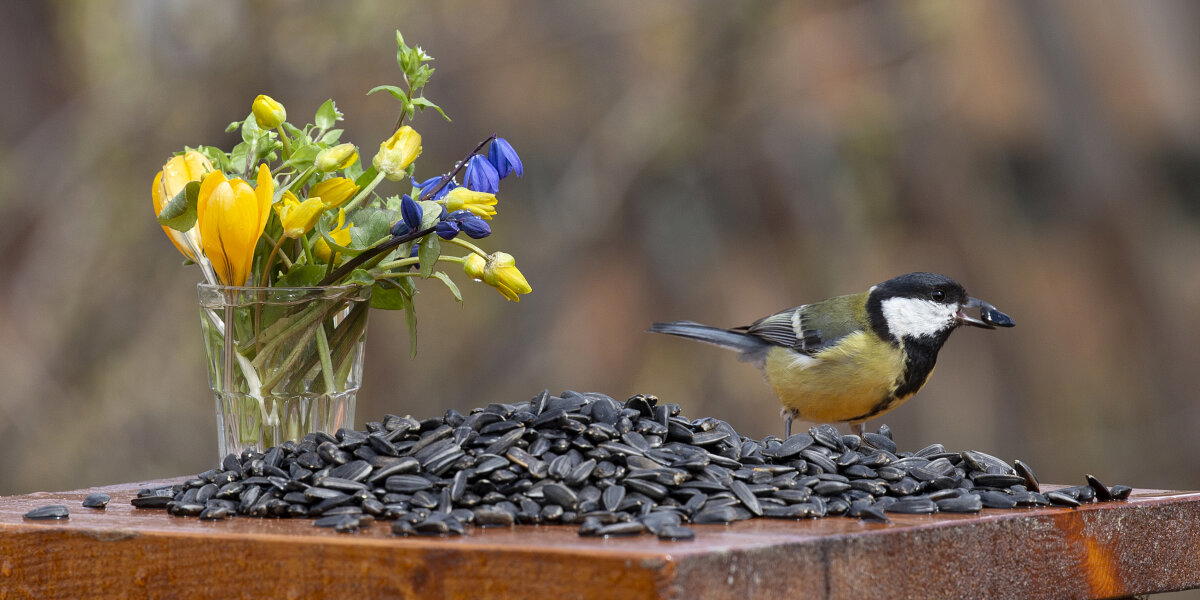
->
(650, 272), (1015, 436)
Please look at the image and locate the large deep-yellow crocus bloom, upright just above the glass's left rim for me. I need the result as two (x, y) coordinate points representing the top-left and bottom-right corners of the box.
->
(196, 164), (275, 286)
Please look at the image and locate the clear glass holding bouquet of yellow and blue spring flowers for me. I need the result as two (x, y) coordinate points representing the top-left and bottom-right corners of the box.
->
(151, 31), (532, 456)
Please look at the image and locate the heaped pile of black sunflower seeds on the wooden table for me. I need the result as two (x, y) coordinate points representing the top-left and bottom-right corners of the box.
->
(124, 391), (1132, 540)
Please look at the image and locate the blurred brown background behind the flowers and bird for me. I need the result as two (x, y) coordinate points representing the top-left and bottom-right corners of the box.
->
(0, 0), (1200, 520)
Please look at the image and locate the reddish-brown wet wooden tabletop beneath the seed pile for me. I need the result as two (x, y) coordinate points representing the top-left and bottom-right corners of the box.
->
(0, 481), (1200, 600)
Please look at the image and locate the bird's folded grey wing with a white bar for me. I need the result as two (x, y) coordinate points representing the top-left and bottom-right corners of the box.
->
(736, 296), (865, 355)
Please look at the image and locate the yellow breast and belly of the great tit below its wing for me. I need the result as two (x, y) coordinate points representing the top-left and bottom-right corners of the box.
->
(763, 331), (906, 422)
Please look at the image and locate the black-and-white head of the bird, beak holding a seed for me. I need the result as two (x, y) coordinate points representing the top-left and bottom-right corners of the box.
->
(866, 272), (1014, 346)
